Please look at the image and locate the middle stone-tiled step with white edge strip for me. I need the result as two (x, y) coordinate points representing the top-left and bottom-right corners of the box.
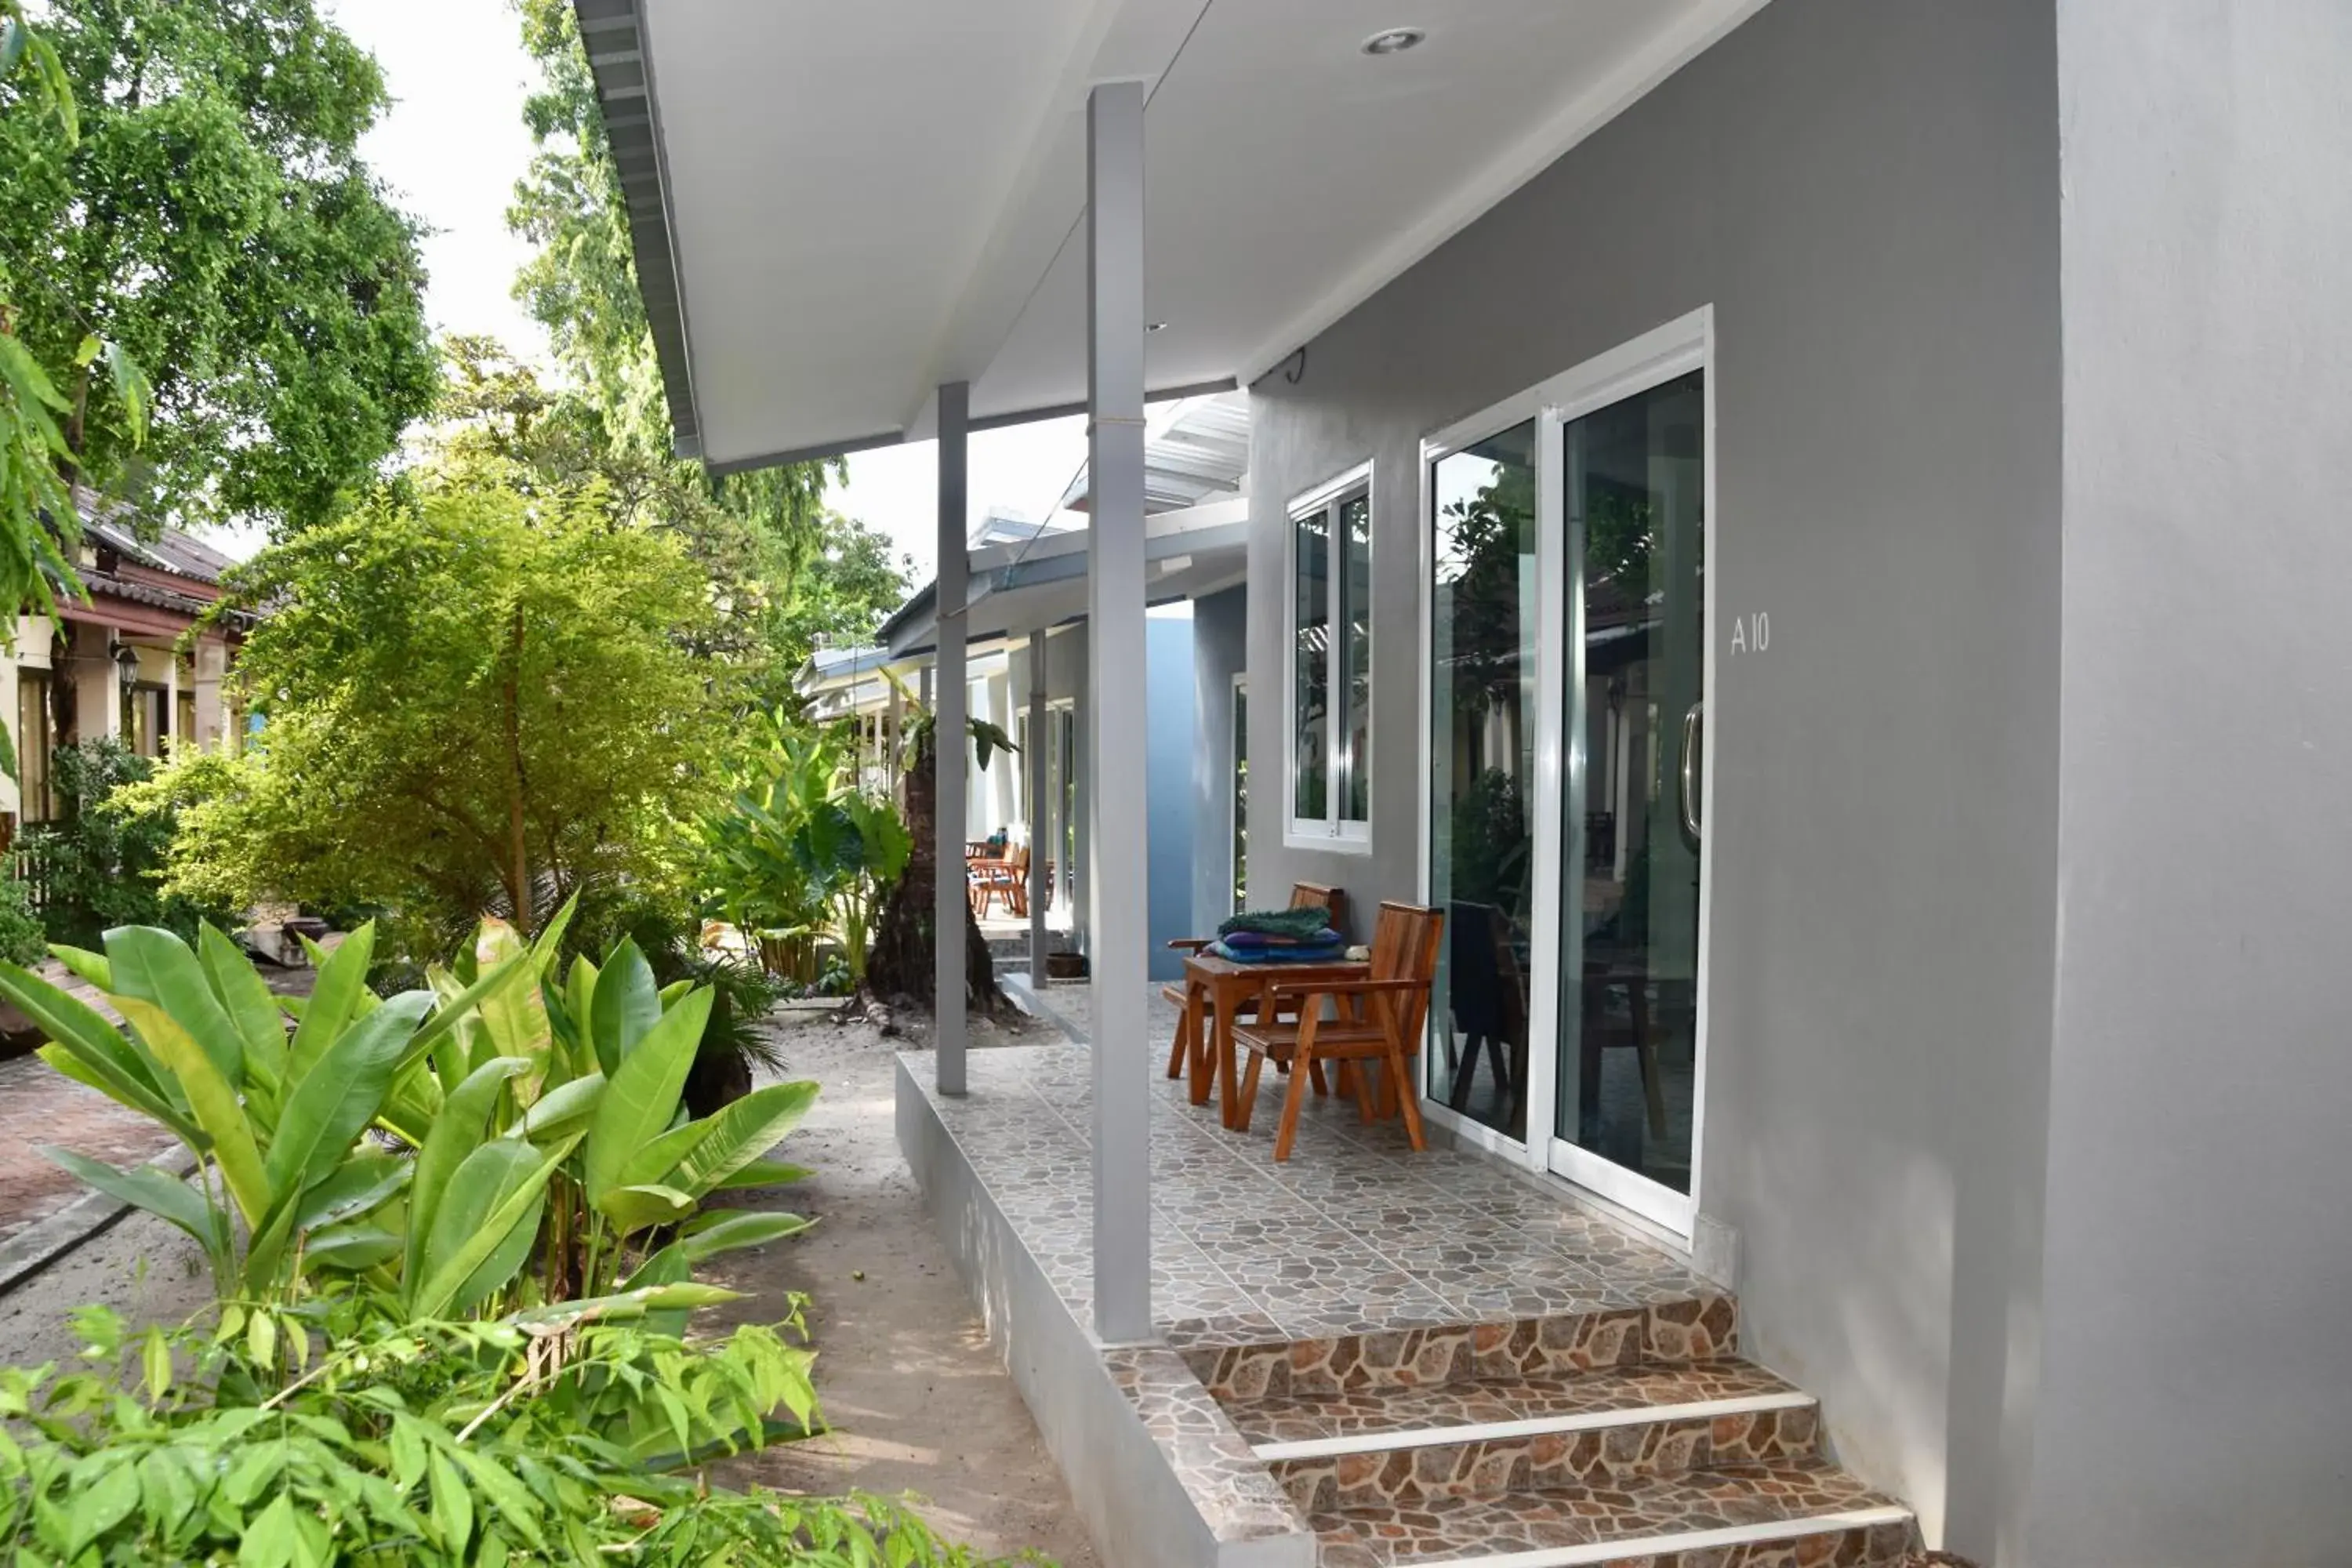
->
(1225, 1359), (1820, 1514)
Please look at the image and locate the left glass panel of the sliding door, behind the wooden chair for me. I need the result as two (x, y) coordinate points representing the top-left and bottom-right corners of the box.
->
(1428, 423), (1536, 1140)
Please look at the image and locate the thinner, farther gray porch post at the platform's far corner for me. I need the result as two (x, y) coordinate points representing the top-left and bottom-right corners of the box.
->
(931, 381), (971, 1095)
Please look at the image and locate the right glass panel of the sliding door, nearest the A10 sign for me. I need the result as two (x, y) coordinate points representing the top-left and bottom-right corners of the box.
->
(1552, 372), (1708, 1222)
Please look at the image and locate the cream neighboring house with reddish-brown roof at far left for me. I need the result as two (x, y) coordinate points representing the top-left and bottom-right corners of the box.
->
(0, 501), (240, 837)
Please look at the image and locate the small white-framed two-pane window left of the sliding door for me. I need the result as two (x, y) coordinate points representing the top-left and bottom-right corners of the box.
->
(1291, 485), (1371, 841)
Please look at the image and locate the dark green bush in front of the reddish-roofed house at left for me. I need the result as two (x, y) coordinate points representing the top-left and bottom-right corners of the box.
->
(19, 736), (238, 947)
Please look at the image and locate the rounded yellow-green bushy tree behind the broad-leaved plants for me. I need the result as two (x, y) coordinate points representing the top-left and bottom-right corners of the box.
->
(134, 475), (734, 938)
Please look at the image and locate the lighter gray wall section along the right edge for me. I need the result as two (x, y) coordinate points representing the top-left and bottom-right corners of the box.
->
(2002, 0), (2352, 1568)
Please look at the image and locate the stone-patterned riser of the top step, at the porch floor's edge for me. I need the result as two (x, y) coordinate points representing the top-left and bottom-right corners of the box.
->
(1183, 1290), (1740, 1403)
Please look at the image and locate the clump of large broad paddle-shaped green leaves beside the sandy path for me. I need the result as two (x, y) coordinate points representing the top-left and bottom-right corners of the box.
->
(0, 912), (816, 1319)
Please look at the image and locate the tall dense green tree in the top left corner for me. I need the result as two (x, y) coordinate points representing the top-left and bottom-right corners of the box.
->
(0, 0), (433, 529)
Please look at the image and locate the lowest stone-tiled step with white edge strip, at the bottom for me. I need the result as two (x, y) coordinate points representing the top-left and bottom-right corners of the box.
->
(1310, 1460), (1919, 1568)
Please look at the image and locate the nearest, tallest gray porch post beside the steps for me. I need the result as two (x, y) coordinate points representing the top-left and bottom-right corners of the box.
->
(1087, 82), (1152, 1345)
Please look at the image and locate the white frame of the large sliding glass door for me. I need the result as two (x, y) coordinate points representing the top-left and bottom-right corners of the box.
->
(1418, 306), (1722, 1236)
